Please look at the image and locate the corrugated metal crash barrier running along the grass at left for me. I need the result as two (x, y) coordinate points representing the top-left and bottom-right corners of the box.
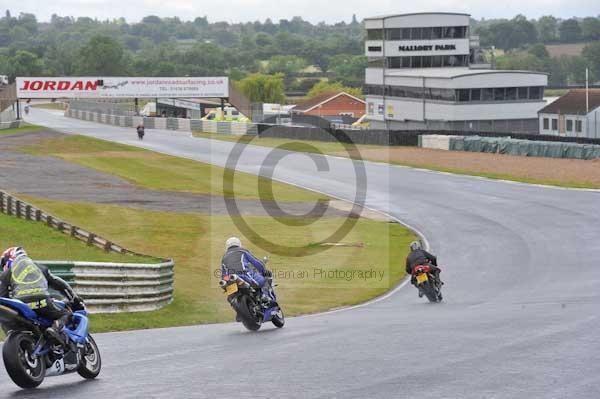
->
(0, 191), (174, 313)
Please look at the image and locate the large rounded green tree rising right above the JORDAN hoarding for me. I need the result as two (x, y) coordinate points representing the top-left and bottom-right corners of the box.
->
(77, 35), (126, 76)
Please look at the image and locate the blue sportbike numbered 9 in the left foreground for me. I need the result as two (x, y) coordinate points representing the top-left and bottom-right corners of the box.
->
(0, 298), (102, 388)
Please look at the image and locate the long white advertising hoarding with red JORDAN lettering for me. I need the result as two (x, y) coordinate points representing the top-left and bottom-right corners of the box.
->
(17, 77), (229, 98)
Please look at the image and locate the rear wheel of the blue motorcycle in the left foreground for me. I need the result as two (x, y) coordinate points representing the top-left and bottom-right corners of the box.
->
(2, 332), (46, 389)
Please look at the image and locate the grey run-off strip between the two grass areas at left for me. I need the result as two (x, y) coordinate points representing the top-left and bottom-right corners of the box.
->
(0, 131), (348, 217)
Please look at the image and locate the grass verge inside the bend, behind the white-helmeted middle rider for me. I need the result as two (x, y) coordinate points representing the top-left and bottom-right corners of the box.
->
(17, 196), (414, 332)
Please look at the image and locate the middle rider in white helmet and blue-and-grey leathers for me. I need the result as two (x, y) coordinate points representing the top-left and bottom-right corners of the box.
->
(221, 237), (273, 302)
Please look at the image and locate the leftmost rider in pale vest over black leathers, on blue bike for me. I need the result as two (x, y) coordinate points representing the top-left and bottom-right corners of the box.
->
(0, 247), (82, 343)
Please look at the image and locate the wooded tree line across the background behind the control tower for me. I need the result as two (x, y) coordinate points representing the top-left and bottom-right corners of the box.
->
(0, 11), (600, 98)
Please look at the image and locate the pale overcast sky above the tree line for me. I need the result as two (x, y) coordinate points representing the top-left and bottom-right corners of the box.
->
(0, 0), (600, 23)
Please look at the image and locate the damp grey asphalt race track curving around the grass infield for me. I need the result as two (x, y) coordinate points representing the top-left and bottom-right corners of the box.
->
(0, 109), (600, 399)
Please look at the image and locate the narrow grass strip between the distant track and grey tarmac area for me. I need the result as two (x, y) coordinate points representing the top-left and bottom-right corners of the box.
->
(21, 135), (327, 201)
